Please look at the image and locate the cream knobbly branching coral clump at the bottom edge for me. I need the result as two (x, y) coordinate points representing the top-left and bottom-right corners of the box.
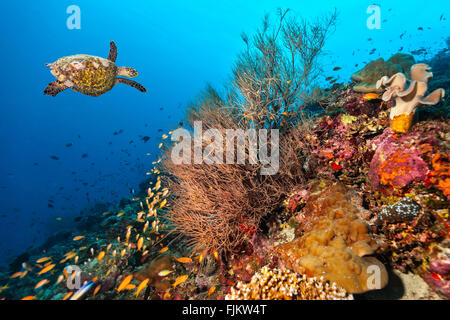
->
(225, 266), (353, 300)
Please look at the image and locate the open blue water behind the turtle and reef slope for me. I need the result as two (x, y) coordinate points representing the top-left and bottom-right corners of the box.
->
(0, 0), (450, 265)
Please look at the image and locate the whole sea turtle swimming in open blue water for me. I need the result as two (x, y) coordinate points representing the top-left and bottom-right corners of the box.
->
(44, 41), (147, 97)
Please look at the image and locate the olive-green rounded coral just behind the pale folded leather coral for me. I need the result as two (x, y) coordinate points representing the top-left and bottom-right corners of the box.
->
(351, 53), (415, 93)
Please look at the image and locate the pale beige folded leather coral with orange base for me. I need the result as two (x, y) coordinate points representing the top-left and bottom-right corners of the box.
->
(376, 63), (445, 133)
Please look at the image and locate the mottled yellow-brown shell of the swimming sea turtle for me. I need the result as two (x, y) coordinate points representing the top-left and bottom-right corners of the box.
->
(53, 54), (117, 96)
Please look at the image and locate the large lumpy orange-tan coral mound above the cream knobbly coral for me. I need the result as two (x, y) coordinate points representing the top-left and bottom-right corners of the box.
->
(274, 181), (388, 293)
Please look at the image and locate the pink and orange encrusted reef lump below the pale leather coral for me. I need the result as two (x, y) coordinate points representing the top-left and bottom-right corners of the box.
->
(368, 123), (450, 197)
